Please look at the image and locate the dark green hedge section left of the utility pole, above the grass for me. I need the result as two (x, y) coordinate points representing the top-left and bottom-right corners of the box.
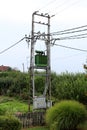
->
(0, 71), (29, 100)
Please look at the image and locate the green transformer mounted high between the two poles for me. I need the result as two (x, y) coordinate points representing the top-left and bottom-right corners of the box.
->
(35, 51), (47, 67)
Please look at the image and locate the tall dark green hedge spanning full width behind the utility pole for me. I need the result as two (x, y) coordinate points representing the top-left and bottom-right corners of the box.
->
(0, 71), (87, 104)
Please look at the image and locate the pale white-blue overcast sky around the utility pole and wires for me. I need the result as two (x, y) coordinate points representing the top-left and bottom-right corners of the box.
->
(0, 0), (87, 73)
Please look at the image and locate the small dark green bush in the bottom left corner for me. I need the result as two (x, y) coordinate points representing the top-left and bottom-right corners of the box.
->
(0, 116), (22, 130)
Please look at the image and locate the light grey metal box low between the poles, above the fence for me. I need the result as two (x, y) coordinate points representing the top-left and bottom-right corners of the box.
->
(33, 96), (46, 109)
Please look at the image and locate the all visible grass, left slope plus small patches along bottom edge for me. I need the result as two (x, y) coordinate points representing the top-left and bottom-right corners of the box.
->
(0, 96), (87, 130)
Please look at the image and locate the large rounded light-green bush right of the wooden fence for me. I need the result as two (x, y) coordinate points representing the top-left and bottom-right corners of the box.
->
(46, 100), (87, 130)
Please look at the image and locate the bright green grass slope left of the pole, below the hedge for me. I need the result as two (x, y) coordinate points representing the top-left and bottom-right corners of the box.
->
(0, 96), (28, 113)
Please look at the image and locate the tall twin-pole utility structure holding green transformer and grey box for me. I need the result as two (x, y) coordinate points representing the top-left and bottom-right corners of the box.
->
(30, 11), (52, 109)
